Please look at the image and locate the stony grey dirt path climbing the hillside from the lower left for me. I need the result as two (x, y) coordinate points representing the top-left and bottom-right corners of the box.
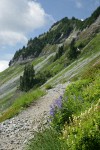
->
(0, 83), (68, 150)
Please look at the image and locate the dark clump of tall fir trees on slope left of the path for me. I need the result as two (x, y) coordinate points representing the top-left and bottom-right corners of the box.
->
(20, 64), (35, 92)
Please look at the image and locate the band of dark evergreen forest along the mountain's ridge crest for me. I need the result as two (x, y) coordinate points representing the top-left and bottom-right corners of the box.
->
(10, 7), (100, 65)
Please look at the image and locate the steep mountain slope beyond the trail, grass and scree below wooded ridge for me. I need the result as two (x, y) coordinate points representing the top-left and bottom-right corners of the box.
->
(0, 7), (100, 115)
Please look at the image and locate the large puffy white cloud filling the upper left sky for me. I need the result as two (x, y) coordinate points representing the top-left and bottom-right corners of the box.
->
(0, 0), (54, 46)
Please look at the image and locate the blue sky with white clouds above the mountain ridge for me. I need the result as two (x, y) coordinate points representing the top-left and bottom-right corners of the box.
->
(0, 0), (100, 72)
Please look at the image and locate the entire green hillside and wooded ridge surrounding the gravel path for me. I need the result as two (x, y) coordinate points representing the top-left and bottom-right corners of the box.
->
(0, 7), (100, 150)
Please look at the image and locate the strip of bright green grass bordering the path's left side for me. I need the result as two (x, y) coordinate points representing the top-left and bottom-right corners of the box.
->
(0, 89), (45, 122)
